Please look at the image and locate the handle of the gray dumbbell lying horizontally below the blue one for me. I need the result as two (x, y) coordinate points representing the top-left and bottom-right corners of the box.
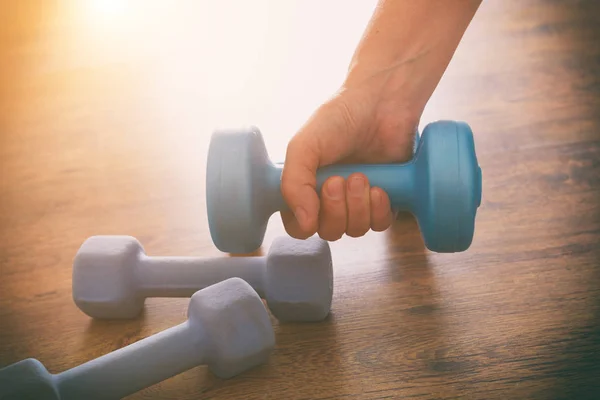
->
(136, 255), (266, 297)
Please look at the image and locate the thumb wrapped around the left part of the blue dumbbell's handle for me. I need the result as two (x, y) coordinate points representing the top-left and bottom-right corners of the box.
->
(281, 98), (352, 239)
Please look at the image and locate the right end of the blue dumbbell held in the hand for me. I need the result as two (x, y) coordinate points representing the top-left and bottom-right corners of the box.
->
(417, 121), (482, 253)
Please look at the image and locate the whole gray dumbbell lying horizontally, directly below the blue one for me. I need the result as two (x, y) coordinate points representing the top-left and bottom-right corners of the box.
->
(73, 236), (333, 322)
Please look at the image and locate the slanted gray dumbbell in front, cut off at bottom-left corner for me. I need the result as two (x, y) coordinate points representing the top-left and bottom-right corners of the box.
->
(0, 278), (275, 400)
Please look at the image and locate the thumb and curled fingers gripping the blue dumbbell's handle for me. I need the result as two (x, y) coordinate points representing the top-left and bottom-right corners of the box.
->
(281, 89), (398, 241)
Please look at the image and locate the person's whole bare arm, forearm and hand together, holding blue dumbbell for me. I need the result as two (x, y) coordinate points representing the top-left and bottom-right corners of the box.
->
(281, 0), (481, 241)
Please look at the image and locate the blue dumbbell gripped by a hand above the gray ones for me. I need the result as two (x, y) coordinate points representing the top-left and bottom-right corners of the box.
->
(206, 121), (482, 253)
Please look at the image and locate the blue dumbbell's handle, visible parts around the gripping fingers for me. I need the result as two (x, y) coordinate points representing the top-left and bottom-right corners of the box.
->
(267, 161), (416, 212)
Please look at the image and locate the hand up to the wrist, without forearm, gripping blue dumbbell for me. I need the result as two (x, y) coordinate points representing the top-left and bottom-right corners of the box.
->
(281, 74), (421, 241)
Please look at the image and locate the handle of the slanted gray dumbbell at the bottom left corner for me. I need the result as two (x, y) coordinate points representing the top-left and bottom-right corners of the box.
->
(54, 321), (208, 400)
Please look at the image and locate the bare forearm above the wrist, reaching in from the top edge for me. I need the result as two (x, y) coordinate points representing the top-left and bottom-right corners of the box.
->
(345, 0), (482, 111)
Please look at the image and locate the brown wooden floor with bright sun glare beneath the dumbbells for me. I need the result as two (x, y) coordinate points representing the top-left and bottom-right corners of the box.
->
(0, 0), (600, 400)
